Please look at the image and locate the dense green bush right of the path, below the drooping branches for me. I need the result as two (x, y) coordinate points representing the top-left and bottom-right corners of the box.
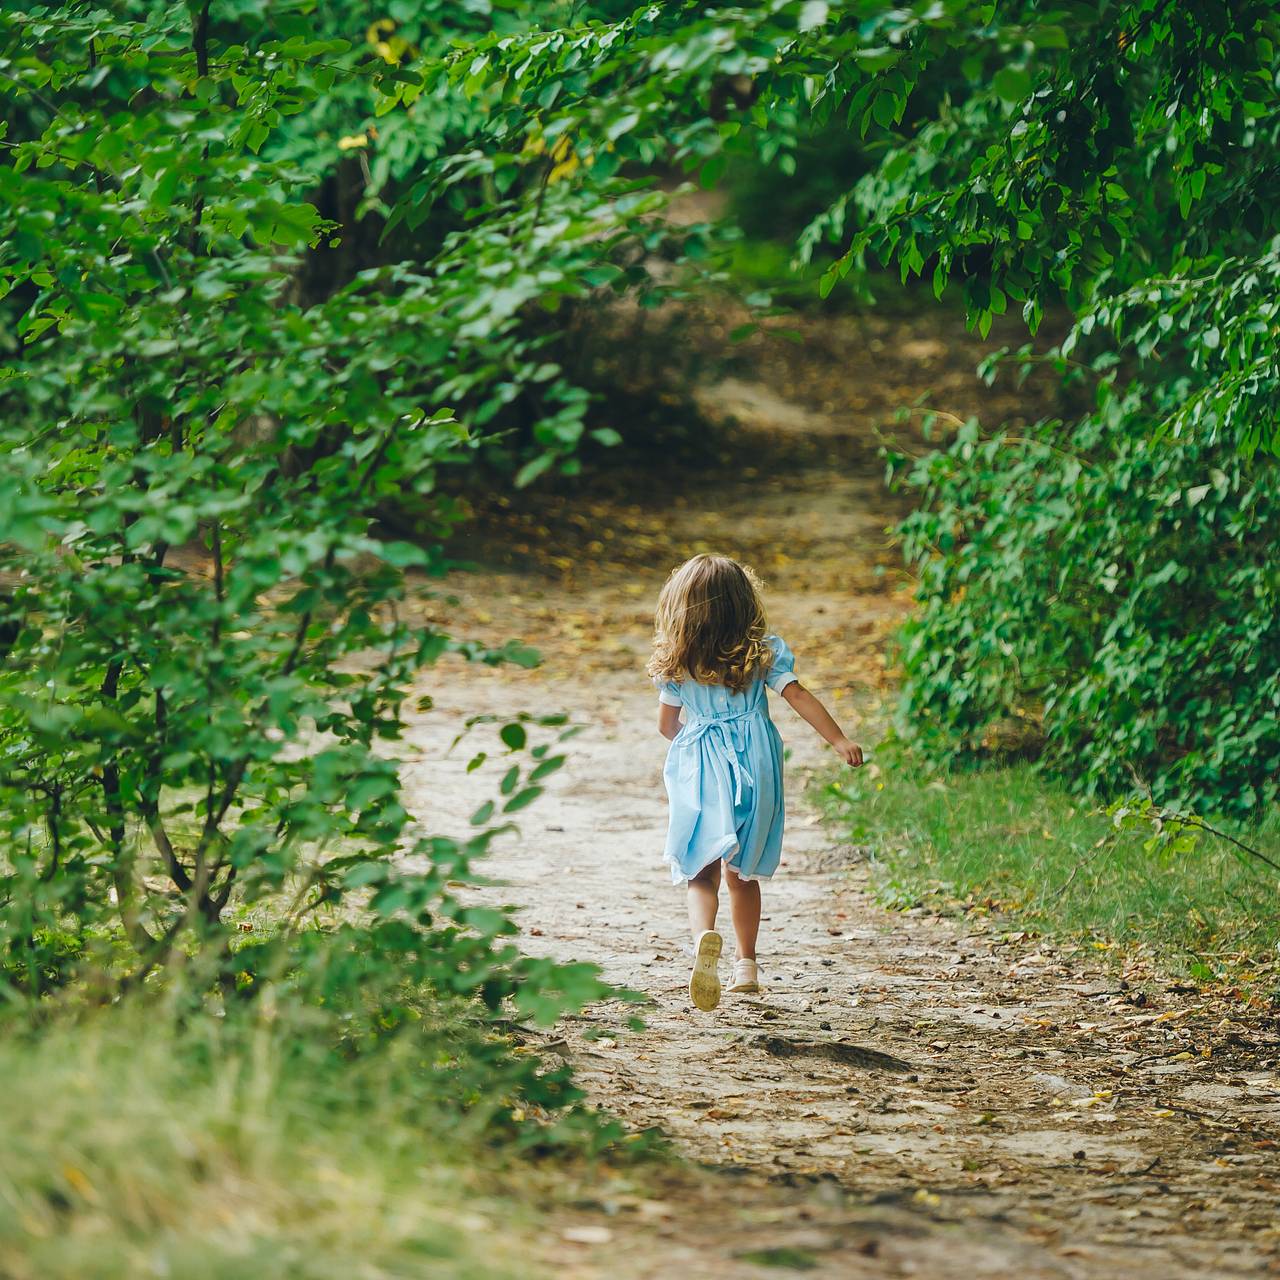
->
(897, 387), (1280, 817)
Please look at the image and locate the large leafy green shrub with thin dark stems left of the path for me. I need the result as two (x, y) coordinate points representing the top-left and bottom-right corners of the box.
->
(0, 4), (629, 1044)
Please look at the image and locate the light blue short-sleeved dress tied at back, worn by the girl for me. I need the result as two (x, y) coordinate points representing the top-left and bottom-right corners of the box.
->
(658, 636), (797, 884)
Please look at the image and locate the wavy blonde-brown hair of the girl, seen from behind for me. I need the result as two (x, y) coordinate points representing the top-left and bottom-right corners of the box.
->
(646, 556), (773, 692)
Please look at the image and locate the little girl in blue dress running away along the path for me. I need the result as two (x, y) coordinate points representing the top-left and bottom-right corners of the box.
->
(648, 556), (863, 1009)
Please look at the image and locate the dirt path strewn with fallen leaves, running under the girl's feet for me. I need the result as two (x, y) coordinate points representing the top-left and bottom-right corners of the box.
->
(407, 312), (1280, 1280)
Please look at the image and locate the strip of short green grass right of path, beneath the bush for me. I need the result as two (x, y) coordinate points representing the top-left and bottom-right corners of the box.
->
(819, 755), (1280, 997)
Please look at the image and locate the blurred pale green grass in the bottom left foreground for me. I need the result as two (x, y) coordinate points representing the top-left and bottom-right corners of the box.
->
(0, 1001), (558, 1280)
